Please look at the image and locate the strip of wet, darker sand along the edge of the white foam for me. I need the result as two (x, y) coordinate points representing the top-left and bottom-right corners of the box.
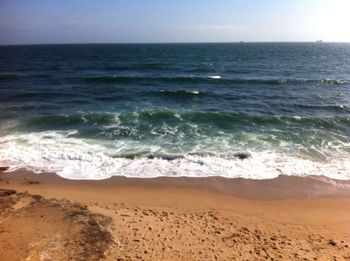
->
(0, 169), (350, 200)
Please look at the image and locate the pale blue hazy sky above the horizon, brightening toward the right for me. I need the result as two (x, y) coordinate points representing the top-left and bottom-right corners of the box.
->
(0, 0), (350, 44)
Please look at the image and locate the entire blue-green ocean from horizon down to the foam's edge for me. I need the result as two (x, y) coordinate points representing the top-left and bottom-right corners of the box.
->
(0, 43), (350, 179)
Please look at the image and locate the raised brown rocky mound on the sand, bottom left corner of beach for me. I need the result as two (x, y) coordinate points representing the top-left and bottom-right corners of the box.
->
(0, 190), (114, 261)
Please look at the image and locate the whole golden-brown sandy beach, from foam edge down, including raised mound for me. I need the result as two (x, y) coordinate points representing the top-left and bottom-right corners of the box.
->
(0, 170), (350, 260)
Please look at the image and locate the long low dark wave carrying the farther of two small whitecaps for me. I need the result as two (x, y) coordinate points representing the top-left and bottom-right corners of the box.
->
(84, 75), (348, 85)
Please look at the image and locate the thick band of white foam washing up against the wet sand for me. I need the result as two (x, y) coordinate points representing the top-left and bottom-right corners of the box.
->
(0, 132), (350, 180)
